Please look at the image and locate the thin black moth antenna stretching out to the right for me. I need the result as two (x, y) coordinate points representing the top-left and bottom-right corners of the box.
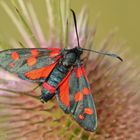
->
(82, 48), (123, 61)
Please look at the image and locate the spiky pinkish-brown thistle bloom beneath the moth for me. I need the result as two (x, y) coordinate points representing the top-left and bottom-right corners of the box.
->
(0, 0), (140, 140)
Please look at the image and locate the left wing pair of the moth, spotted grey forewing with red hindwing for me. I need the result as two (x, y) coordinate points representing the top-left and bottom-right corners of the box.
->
(0, 48), (61, 82)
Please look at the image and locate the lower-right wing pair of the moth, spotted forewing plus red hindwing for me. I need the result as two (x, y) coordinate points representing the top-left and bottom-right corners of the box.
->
(56, 64), (97, 131)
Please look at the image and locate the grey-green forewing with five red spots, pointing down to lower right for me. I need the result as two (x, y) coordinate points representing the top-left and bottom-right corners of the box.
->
(69, 65), (97, 131)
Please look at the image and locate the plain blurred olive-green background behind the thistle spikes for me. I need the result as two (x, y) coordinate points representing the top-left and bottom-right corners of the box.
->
(0, 0), (140, 64)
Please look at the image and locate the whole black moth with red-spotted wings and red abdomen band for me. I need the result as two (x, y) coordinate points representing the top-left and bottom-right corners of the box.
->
(0, 10), (122, 131)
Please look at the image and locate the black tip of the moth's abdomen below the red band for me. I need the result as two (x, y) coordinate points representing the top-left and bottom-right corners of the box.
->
(40, 87), (55, 103)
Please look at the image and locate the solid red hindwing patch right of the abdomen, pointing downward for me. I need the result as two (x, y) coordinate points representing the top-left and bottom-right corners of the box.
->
(59, 72), (70, 107)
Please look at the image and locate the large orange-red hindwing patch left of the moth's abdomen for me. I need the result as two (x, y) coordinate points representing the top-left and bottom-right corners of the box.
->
(25, 62), (58, 80)
